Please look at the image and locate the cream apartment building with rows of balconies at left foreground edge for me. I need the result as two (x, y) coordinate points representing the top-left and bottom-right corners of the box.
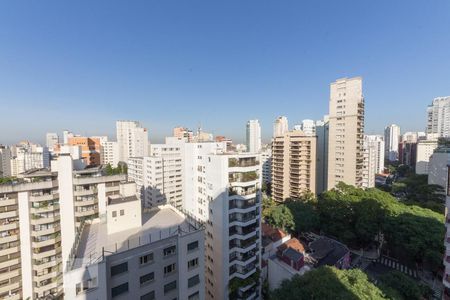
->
(0, 154), (126, 299)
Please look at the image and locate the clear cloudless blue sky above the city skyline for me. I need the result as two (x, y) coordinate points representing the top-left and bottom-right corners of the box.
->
(0, 0), (450, 143)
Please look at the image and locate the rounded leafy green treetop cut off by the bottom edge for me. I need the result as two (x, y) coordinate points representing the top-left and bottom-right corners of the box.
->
(271, 266), (388, 300)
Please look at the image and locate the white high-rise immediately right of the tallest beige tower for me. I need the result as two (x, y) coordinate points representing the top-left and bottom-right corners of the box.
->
(363, 135), (384, 187)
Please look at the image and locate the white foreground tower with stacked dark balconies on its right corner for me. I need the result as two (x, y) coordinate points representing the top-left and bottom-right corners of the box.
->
(183, 143), (261, 299)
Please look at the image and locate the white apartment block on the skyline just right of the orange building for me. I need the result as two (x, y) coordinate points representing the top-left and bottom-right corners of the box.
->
(116, 121), (148, 162)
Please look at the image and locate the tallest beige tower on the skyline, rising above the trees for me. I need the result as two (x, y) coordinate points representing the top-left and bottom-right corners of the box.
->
(327, 77), (364, 189)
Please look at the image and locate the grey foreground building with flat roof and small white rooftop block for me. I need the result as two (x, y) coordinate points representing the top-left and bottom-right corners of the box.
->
(64, 200), (205, 300)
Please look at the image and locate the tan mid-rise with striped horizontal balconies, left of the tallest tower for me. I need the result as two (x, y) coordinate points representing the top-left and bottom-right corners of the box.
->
(272, 130), (317, 202)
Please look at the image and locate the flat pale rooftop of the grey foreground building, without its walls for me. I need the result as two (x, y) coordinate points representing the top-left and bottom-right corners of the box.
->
(72, 206), (199, 268)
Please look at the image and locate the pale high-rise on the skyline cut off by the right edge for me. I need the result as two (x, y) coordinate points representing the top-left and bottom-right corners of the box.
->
(427, 96), (450, 137)
